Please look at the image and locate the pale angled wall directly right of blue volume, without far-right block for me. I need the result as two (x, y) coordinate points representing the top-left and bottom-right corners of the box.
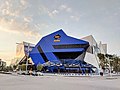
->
(82, 35), (100, 69)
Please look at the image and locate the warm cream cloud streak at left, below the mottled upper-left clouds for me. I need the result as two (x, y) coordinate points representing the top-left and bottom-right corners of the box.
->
(0, 18), (38, 36)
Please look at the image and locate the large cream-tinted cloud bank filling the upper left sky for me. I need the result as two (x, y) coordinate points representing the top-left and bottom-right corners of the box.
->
(0, 0), (39, 37)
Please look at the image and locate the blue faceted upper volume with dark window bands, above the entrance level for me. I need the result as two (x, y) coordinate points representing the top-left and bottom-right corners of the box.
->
(30, 30), (89, 65)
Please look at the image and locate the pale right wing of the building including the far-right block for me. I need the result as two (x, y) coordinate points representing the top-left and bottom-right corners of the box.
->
(82, 35), (107, 70)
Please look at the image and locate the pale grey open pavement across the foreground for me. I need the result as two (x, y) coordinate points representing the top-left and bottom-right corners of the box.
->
(0, 74), (120, 90)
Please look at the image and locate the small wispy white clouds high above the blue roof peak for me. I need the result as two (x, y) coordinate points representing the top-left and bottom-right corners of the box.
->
(39, 4), (82, 22)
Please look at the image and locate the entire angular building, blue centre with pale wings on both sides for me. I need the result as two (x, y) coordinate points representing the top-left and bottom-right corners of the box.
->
(12, 30), (107, 73)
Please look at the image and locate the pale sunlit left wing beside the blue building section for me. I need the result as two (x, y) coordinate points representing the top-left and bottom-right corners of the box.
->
(11, 41), (35, 66)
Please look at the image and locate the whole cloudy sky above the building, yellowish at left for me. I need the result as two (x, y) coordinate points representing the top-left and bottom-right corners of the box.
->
(0, 0), (120, 63)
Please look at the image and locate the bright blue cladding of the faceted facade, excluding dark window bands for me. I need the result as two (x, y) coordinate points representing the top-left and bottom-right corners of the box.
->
(30, 30), (89, 65)
